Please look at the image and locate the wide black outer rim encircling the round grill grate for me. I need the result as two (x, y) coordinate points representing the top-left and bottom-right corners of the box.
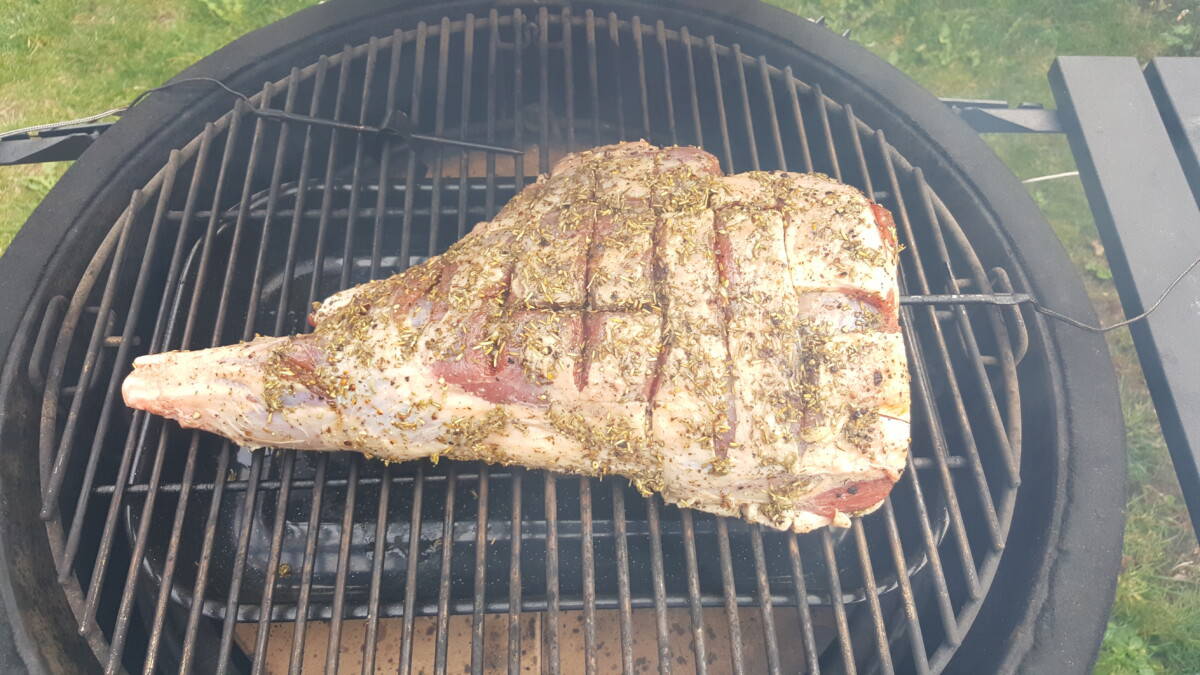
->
(0, 0), (1124, 667)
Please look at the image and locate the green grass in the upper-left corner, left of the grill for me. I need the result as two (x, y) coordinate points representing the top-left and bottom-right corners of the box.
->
(0, 0), (313, 243)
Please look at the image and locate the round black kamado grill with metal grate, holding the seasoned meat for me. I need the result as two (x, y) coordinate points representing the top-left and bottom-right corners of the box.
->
(0, 0), (1124, 673)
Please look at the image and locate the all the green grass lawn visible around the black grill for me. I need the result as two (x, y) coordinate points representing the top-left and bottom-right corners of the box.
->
(0, 0), (1200, 674)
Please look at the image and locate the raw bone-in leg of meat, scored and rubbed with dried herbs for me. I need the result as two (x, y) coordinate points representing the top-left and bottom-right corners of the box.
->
(122, 142), (910, 532)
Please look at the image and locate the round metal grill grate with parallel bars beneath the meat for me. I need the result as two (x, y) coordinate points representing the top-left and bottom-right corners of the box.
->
(39, 7), (1028, 673)
